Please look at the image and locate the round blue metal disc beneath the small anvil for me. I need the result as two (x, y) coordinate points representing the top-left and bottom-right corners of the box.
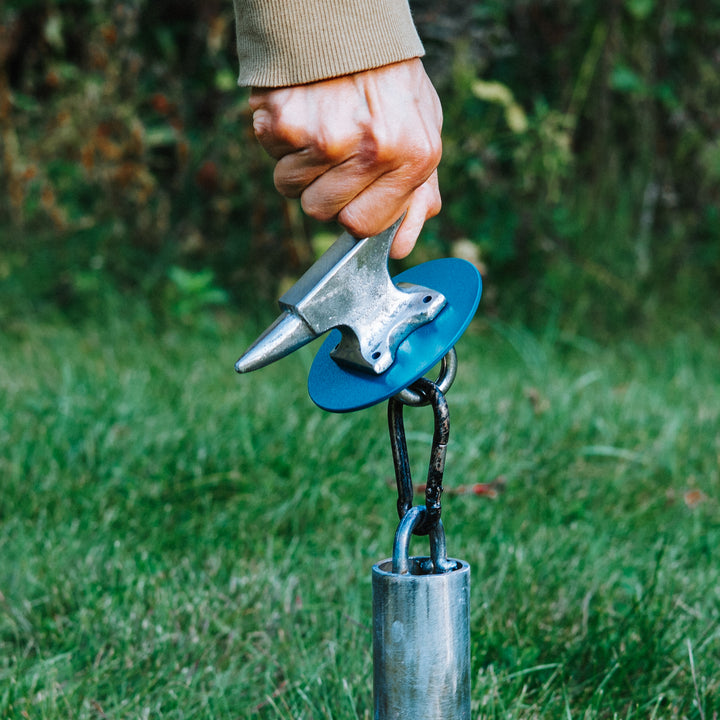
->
(308, 258), (482, 412)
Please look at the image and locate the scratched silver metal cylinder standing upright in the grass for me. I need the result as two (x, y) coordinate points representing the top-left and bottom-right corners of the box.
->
(372, 558), (470, 720)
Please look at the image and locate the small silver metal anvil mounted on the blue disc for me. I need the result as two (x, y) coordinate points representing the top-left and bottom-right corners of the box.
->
(235, 219), (446, 375)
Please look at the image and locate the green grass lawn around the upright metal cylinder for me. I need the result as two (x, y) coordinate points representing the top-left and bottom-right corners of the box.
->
(0, 308), (720, 720)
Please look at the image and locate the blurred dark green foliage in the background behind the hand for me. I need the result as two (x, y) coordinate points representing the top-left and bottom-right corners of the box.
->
(0, 0), (720, 332)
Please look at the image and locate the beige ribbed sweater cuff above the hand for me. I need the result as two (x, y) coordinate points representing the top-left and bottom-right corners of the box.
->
(234, 0), (423, 87)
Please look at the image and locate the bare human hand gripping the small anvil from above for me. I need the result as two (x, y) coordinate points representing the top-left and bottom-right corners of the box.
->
(250, 58), (442, 258)
